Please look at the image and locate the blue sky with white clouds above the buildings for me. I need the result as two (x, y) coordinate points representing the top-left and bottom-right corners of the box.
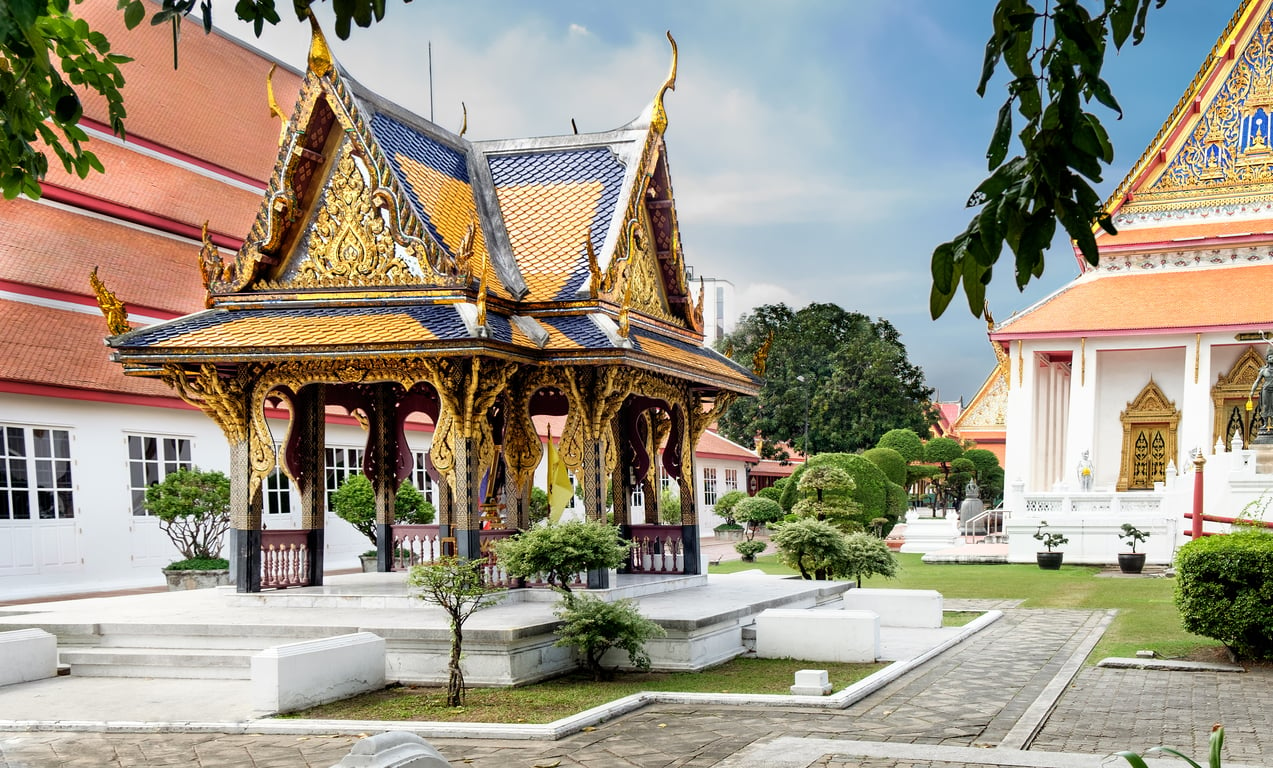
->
(214, 0), (1237, 400)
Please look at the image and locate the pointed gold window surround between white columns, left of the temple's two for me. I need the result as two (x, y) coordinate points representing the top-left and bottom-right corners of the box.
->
(1118, 378), (1180, 490)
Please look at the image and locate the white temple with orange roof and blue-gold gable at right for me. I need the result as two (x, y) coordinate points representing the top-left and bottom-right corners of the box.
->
(979, 0), (1273, 565)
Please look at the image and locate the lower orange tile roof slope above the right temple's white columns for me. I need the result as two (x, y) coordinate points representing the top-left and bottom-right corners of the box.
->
(992, 265), (1273, 339)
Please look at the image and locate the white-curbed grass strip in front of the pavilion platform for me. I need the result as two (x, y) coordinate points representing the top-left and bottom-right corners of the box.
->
(285, 658), (886, 723)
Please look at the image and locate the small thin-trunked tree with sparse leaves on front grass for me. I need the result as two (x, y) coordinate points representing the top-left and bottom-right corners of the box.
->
(407, 558), (495, 707)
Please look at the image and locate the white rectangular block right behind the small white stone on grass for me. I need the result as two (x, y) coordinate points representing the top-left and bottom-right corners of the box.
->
(756, 608), (880, 662)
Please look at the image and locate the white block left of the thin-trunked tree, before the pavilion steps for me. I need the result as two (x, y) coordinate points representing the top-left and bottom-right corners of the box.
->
(252, 632), (384, 713)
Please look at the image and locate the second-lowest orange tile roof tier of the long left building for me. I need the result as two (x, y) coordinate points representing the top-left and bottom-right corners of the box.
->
(0, 199), (204, 318)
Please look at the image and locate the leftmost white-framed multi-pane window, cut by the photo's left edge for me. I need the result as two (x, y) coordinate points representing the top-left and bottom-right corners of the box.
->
(0, 423), (75, 522)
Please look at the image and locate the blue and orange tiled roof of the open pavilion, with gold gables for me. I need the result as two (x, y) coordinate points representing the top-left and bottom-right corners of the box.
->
(103, 22), (756, 392)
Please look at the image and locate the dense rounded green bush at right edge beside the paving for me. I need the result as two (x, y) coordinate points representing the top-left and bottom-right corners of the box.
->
(1175, 531), (1273, 658)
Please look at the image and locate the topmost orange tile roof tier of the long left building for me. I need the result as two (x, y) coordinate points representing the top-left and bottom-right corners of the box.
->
(71, 0), (300, 180)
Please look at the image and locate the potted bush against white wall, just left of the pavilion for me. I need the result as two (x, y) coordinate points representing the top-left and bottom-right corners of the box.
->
(145, 467), (230, 590)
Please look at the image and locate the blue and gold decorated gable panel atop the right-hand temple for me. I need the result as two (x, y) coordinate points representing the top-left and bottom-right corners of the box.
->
(1137, 15), (1273, 203)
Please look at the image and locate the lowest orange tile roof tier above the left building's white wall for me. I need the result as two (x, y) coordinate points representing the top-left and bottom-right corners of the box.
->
(0, 299), (173, 397)
